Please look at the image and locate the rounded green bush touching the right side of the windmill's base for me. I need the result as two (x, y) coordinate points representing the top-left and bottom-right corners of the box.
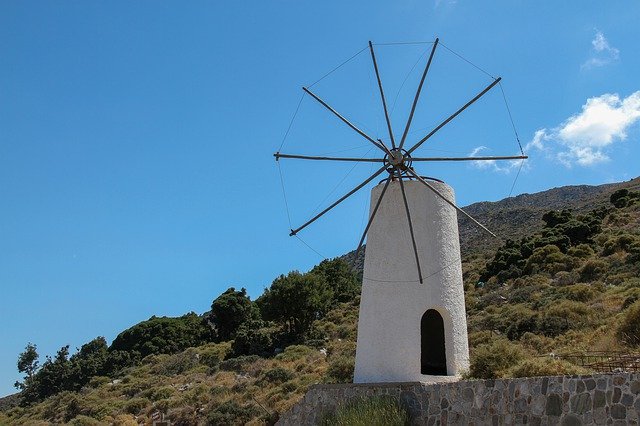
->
(469, 340), (523, 379)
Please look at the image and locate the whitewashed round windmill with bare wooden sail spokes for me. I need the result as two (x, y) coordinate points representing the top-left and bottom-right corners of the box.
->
(274, 39), (527, 383)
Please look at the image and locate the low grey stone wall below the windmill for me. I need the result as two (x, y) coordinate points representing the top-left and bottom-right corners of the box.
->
(277, 373), (640, 426)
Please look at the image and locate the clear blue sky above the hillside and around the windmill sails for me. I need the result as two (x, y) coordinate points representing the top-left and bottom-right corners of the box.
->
(0, 0), (640, 395)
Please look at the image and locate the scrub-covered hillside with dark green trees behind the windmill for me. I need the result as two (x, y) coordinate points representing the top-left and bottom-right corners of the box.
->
(0, 180), (640, 425)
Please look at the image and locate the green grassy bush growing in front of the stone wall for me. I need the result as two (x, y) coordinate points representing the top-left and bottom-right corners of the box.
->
(321, 397), (411, 426)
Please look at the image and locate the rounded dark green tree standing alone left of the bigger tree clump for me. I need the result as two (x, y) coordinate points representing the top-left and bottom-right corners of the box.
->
(208, 287), (256, 341)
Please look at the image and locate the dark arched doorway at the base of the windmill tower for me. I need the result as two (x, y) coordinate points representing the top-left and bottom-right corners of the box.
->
(420, 309), (447, 376)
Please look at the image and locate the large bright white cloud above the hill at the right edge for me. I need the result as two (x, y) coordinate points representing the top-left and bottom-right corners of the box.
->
(525, 91), (640, 167)
